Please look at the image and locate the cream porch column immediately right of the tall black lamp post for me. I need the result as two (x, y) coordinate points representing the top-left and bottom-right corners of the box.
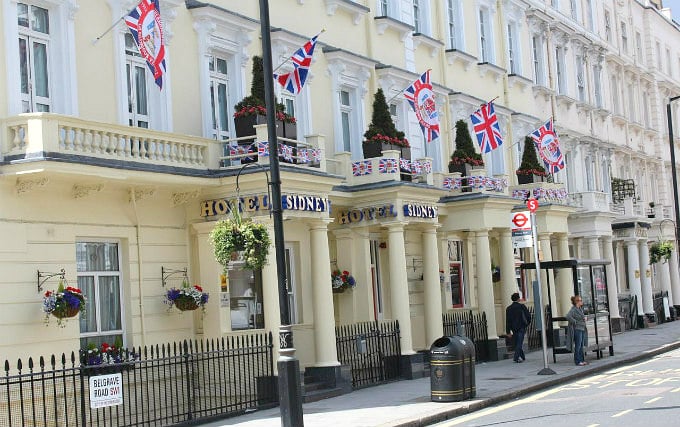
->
(309, 220), (340, 366)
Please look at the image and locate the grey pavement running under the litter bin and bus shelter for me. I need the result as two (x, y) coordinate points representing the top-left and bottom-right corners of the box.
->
(203, 321), (680, 427)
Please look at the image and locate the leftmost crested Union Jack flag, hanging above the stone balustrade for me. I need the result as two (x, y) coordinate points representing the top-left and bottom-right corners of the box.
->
(125, 0), (166, 89)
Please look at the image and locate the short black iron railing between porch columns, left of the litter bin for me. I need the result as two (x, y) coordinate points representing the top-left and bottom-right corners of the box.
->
(335, 321), (401, 389)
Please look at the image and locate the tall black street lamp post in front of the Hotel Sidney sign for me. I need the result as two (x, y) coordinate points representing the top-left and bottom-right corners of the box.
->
(260, 0), (304, 427)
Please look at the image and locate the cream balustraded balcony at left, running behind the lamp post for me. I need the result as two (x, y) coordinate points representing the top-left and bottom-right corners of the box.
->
(0, 113), (326, 177)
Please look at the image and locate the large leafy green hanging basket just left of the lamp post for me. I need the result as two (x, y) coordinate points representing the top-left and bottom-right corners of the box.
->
(210, 208), (271, 270)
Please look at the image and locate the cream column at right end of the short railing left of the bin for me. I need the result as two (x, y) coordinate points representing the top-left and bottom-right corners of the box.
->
(387, 223), (415, 355)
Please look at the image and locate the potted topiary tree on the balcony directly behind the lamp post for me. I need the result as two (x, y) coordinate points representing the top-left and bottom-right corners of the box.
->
(234, 56), (297, 160)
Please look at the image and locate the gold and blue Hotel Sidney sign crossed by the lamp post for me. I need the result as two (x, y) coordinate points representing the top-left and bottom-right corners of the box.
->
(201, 194), (331, 216)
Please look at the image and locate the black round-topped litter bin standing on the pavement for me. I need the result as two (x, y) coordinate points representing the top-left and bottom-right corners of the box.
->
(430, 335), (476, 402)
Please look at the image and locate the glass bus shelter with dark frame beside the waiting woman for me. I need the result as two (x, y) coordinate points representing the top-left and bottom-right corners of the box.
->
(521, 259), (614, 362)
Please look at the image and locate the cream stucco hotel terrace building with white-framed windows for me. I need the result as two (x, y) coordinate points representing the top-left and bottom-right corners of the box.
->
(0, 0), (680, 384)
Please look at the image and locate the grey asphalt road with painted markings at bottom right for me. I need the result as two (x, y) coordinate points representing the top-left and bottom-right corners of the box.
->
(436, 350), (680, 427)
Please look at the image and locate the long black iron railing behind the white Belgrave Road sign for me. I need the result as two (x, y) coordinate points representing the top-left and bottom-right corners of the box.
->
(0, 333), (278, 427)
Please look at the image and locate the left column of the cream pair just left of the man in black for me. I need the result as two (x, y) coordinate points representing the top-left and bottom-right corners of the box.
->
(474, 230), (498, 340)
